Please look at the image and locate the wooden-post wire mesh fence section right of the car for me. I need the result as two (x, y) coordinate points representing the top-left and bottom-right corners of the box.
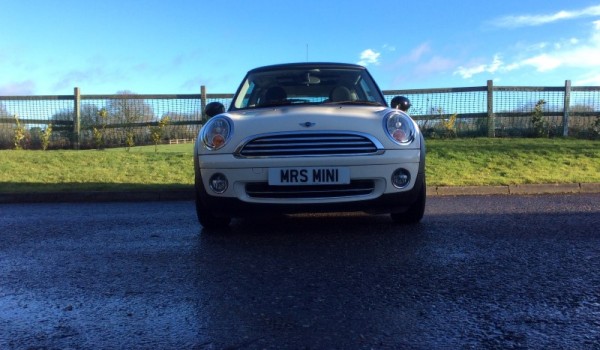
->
(384, 81), (600, 138)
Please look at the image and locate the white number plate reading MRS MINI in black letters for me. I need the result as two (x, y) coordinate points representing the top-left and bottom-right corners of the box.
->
(269, 167), (350, 186)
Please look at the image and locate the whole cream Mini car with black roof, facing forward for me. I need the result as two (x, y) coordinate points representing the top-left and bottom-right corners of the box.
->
(194, 63), (426, 228)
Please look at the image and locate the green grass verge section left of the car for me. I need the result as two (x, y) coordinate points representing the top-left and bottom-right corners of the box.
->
(0, 144), (194, 192)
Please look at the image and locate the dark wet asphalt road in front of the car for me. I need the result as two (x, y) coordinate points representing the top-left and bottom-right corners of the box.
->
(0, 194), (600, 349)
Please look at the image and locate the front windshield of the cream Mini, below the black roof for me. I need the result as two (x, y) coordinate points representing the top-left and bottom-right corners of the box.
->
(230, 67), (386, 110)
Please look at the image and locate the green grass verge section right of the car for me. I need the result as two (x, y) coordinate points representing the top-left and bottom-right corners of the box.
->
(426, 138), (600, 186)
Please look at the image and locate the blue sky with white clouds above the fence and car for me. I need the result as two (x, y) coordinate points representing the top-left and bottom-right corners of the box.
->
(0, 0), (600, 95)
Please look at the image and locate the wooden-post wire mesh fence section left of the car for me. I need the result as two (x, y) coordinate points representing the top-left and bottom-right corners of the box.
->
(0, 91), (232, 149)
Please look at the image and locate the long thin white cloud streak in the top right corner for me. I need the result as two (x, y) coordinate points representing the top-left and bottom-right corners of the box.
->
(492, 5), (600, 28)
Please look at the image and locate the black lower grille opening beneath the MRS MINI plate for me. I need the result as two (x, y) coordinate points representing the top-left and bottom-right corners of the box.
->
(246, 180), (375, 198)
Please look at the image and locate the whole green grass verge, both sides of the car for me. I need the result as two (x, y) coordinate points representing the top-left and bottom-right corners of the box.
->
(0, 138), (600, 192)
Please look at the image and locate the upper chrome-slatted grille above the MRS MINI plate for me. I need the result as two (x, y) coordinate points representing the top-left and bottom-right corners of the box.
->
(238, 133), (379, 157)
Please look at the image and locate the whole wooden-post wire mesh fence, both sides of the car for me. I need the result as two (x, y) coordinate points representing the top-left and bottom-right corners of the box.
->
(0, 81), (600, 149)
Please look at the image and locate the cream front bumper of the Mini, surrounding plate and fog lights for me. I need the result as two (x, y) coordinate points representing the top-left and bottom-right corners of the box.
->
(195, 149), (425, 216)
